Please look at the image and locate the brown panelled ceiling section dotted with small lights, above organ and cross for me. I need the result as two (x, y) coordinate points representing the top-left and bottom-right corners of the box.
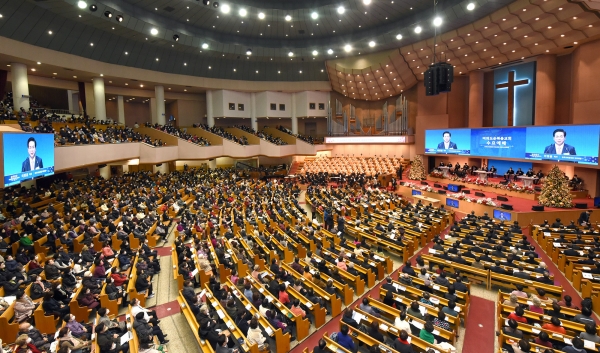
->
(327, 0), (600, 100)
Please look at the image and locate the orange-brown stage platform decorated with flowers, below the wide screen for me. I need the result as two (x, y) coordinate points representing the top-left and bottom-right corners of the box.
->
(396, 178), (600, 226)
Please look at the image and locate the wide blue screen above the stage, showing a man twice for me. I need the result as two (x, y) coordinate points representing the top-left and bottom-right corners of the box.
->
(425, 125), (600, 165)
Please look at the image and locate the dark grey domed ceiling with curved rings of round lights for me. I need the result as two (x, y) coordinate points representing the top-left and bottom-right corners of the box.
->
(0, 0), (511, 81)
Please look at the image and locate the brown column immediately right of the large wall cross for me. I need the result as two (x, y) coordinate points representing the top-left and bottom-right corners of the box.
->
(534, 55), (556, 125)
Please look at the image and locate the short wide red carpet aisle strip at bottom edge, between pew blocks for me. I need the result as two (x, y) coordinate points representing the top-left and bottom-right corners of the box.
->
(462, 296), (496, 353)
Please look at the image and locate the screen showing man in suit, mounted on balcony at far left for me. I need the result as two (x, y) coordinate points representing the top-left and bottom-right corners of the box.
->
(2, 133), (54, 186)
